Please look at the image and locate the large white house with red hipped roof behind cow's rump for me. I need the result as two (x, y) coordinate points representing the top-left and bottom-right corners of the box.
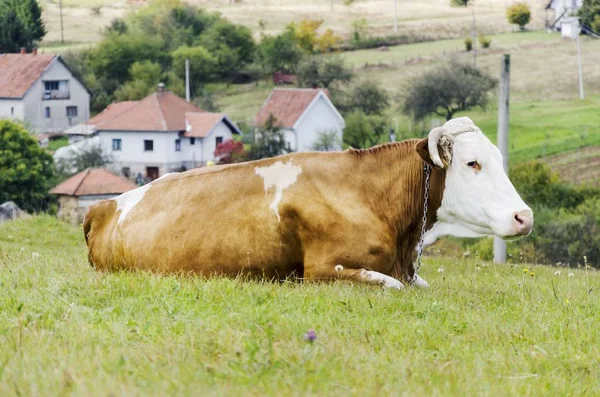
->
(54, 86), (240, 180)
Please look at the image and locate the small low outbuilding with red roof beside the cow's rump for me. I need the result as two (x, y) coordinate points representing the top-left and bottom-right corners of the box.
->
(50, 168), (137, 224)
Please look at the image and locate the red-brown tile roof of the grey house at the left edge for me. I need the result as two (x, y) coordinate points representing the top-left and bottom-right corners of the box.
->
(0, 54), (56, 98)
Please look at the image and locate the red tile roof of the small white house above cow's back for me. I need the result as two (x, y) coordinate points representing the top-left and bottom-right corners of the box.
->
(254, 88), (328, 128)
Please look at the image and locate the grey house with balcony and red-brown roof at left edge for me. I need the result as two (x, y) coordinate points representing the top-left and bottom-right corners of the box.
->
(0, 50), (90, 133)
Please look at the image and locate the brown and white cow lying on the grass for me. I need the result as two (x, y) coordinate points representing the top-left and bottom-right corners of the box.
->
(83, 117), (533, 289)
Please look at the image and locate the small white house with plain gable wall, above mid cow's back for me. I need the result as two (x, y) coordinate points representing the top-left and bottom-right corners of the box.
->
(253, 88), (345, 152)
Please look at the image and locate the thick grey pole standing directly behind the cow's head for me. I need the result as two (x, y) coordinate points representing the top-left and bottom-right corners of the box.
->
(494, 54), (510, 263)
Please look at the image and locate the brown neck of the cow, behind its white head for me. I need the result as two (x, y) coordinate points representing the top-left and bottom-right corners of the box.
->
(346, 140), (446, 276)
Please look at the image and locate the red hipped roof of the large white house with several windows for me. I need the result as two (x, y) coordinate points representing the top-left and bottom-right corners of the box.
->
(95, 92), (203, 131)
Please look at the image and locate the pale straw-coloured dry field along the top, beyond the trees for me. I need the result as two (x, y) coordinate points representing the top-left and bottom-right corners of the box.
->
(38, 0), (547, 42)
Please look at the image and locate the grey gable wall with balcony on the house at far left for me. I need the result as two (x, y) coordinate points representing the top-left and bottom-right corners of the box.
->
(23, 60), (90, 132)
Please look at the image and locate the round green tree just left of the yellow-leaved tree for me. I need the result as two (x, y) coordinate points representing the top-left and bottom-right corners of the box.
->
(258, 30), (304, 73)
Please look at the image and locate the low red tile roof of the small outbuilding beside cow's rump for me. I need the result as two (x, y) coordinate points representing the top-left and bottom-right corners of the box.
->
(50, 168), (137, 196)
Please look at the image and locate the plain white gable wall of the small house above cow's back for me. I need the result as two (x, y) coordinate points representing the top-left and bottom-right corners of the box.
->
(292, 97), (344, 152)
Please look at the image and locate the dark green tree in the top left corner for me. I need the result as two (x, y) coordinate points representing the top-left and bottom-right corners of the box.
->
(0, 0), (46, 53)
